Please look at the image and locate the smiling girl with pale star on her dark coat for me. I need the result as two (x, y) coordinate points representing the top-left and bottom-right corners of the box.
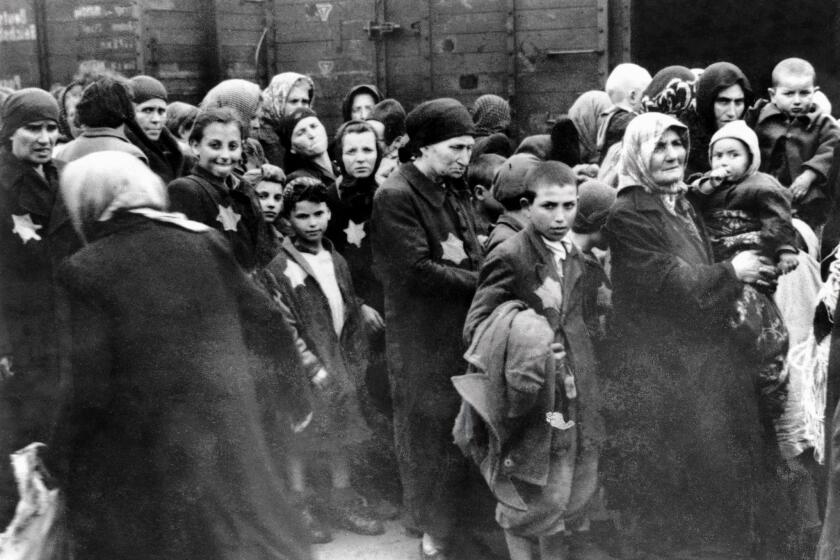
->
(168, 107), (271, 272)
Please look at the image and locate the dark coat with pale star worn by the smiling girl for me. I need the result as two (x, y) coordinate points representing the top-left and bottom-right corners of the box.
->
(168, 166), (271, 271)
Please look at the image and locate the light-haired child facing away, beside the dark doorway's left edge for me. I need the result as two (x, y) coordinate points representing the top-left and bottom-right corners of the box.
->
(597, 62), (653, 164)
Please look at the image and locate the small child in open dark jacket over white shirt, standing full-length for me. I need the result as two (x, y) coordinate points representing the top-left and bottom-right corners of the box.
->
(265, 176), (384, 542)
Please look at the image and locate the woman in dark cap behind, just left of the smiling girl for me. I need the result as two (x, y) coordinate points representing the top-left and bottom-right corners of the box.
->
(126, 75), (188, 184)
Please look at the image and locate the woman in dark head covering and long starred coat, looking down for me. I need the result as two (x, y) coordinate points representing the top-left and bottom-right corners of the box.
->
(371, 99), (482, 560)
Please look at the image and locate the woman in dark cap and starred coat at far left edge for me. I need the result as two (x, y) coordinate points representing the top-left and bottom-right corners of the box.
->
(0, 88), (79, 527)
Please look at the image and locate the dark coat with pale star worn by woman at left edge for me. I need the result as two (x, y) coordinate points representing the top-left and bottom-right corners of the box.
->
(0, 149), (80, 526)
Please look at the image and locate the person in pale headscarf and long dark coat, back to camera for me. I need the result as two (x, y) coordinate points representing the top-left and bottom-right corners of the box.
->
(52, 152), (311, 560)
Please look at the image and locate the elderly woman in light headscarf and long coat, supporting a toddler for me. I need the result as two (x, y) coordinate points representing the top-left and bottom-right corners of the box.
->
(604, 113), (779, 557)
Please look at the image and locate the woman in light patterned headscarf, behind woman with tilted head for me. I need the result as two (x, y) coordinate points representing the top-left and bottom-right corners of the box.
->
(257, 72), (316, 166)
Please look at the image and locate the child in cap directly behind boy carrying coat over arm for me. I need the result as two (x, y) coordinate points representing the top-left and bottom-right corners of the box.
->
(484, 154), (540, 254)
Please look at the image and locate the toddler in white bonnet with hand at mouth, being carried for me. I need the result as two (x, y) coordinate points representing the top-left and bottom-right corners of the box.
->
(692, 121), (799, 417)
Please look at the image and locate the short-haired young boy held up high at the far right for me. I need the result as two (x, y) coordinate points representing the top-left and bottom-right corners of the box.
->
(755, 58), (840, 231)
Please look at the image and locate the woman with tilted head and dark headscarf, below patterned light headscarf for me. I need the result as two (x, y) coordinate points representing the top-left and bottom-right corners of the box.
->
(278, 107), (338, 185)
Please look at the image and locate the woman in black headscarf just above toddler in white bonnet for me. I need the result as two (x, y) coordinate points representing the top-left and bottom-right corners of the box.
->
(682, 62), (754, 175)
